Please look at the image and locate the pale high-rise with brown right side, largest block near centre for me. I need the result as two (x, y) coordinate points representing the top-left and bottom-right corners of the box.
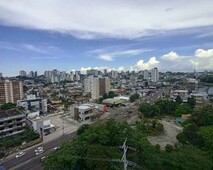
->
(84, 76), (110, 99)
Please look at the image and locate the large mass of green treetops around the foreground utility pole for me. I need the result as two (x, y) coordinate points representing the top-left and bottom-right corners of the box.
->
(43, 119), (213, 170)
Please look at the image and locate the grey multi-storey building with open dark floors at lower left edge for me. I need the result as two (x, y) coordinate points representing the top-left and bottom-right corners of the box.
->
(0, 109), (26, 137)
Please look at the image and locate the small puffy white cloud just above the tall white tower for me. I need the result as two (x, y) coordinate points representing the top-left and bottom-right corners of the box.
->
(136, 57), (160, 70)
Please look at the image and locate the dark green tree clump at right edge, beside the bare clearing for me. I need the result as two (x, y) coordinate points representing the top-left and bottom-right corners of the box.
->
(177, 106), (213, 159)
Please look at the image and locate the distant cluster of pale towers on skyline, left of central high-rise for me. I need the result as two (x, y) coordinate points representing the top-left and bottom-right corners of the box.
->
(44, 69), (81, 83)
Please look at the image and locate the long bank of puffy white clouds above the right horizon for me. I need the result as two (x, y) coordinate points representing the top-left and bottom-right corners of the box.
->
(135, 49), (213, 71)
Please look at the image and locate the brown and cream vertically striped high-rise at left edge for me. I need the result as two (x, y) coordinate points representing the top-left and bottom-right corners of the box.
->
(0, 80), (24, 105)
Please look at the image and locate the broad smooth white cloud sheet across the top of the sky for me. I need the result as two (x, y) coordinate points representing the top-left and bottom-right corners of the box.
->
(0, 0), (213, 39)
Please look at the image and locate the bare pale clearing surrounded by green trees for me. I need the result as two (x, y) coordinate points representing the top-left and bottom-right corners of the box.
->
(148, 117), (183, 148)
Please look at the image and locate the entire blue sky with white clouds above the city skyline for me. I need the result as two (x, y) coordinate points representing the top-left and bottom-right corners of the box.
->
(0, 0), (213, 76)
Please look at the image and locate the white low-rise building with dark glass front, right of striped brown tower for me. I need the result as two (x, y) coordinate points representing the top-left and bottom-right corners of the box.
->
(17, 95), (47, 114)
